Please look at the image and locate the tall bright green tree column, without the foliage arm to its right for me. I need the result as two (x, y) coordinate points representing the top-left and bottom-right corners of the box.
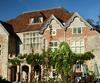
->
(53, 42), (72, 83)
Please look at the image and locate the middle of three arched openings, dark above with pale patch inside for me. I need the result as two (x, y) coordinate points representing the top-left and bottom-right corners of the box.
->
(22, 65), (29, 82)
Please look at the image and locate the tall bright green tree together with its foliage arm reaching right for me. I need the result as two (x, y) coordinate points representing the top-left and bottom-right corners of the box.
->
(52, 42), (94, 83)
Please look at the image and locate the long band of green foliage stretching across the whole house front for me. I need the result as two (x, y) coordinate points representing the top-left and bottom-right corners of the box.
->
(9, 42), (94, 82)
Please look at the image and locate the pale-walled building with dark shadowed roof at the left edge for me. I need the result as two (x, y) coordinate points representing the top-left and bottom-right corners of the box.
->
(0, 21), (19, 78)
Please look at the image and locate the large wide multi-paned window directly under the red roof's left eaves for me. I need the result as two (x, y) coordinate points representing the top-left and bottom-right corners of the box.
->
(23, 32), (42, 50)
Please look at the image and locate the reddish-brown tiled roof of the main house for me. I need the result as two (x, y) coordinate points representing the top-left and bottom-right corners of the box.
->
(7, 8), (72, 32)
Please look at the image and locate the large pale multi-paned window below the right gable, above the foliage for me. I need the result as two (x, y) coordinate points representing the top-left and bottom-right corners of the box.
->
(70, 39), (85, 53)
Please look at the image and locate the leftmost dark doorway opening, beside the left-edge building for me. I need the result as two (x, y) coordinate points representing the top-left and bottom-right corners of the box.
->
(10, 66), (17, 82)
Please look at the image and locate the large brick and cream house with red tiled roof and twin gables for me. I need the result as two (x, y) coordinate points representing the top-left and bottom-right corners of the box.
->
(0, 8), (100, 81)
